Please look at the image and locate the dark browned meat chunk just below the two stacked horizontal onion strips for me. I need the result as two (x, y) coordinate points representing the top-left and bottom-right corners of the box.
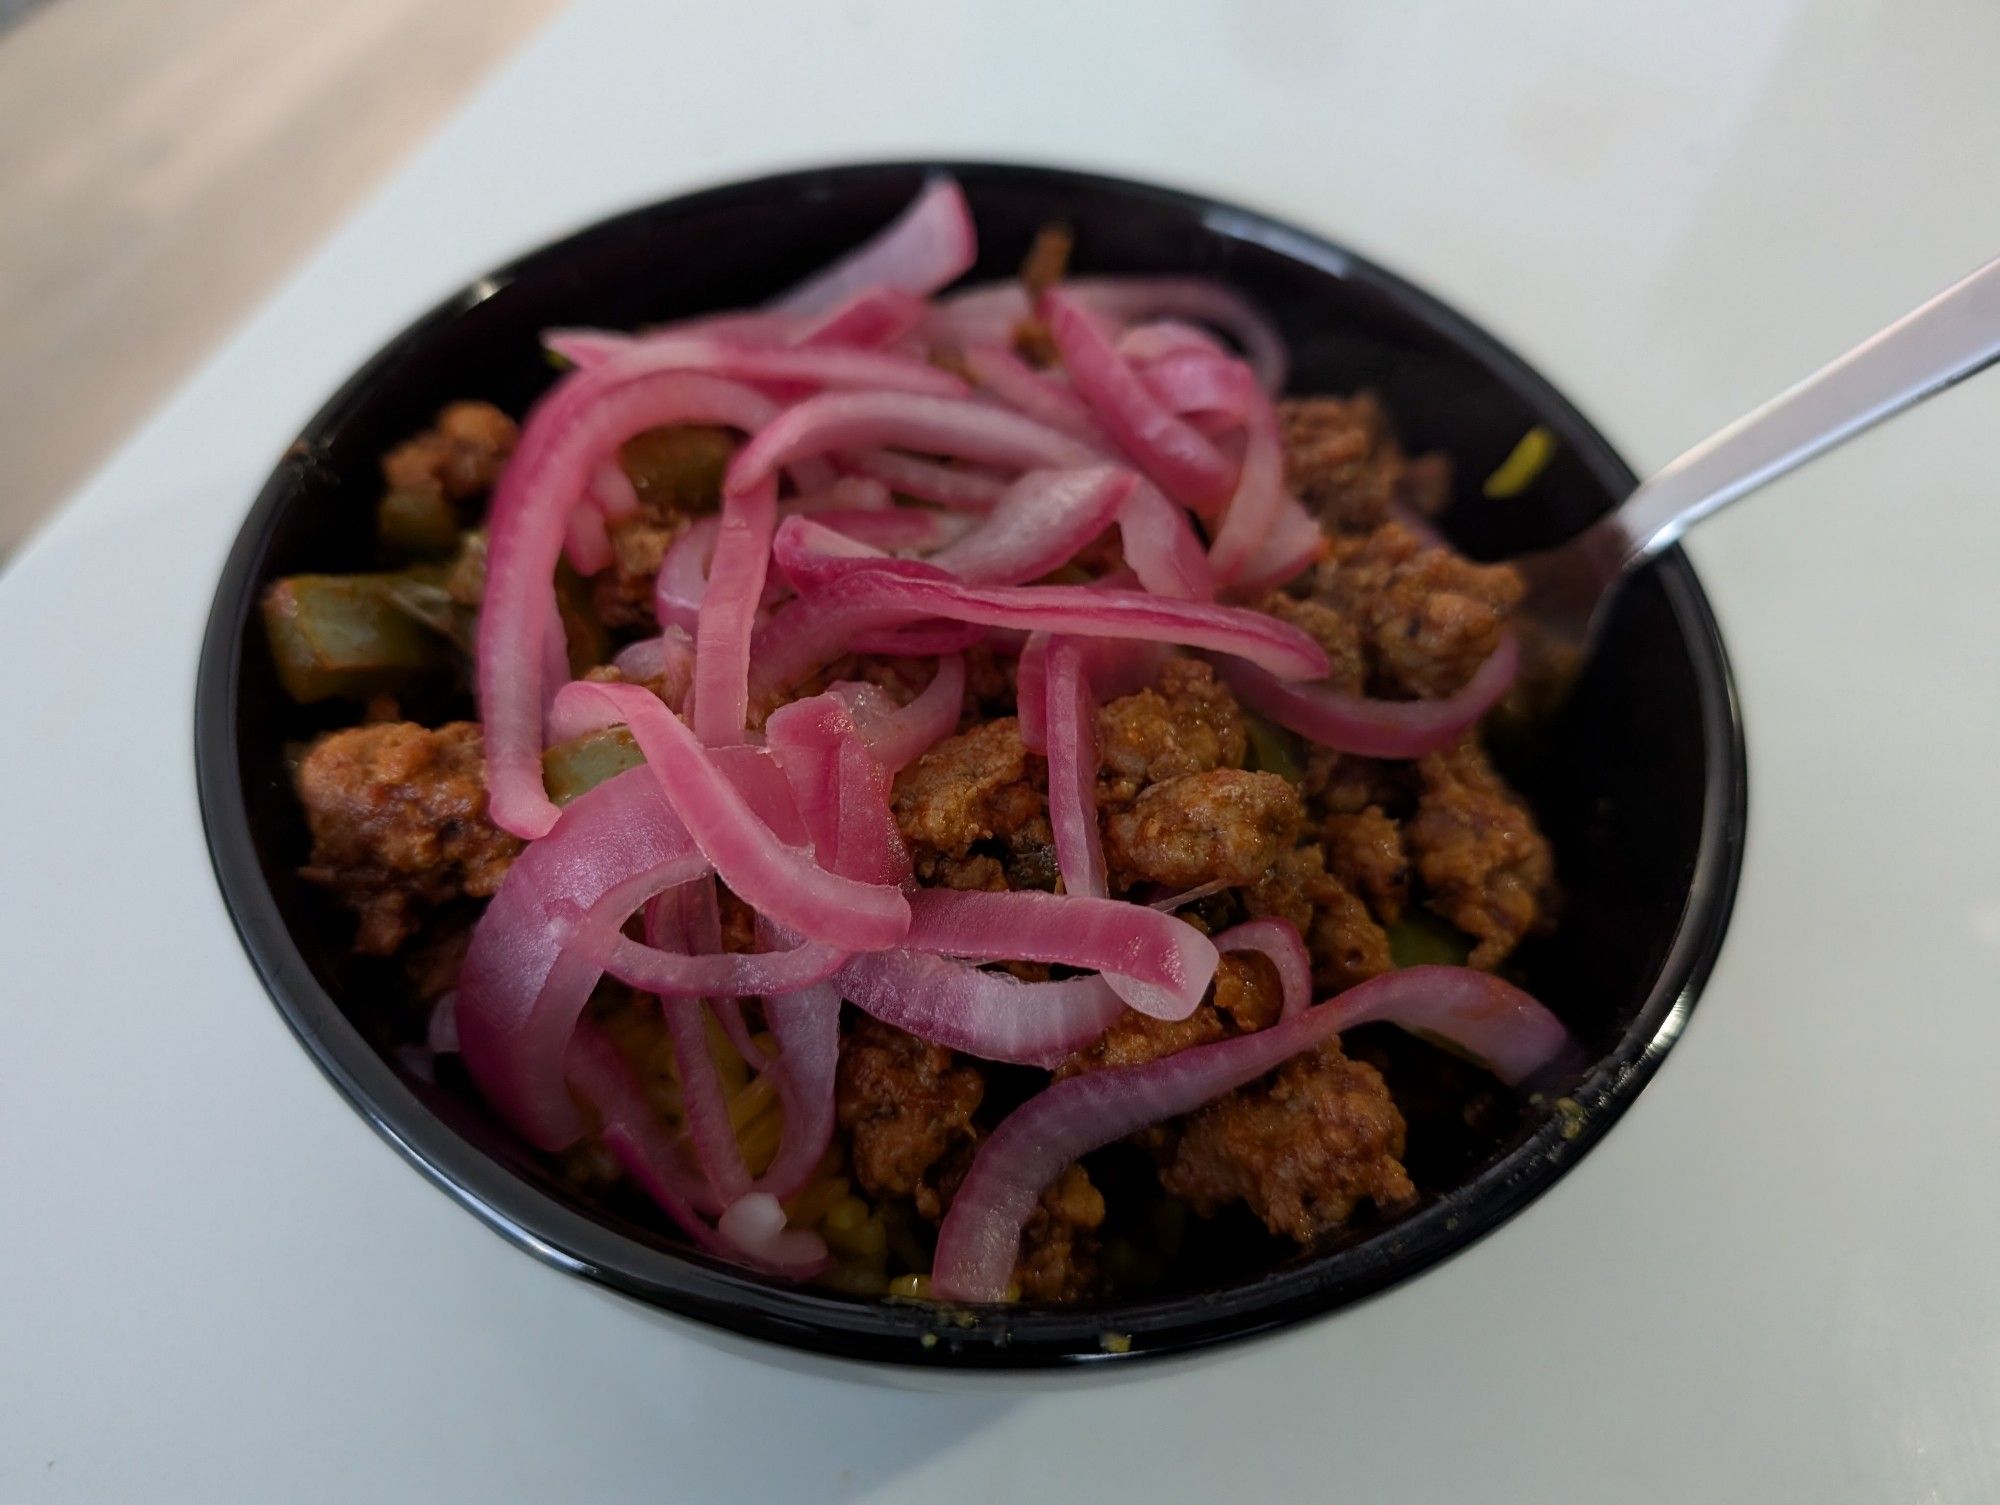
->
(834, 1017), (986, 1197)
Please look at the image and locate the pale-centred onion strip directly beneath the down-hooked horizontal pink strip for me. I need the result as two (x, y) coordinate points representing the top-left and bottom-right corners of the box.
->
(836, 951), (1124, 1069)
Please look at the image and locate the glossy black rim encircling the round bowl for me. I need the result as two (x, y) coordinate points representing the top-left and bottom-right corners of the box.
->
(194, 160), (1748, 1371)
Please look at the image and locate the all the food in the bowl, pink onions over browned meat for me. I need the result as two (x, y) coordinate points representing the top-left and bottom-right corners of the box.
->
(264, 180), (1570, 1301)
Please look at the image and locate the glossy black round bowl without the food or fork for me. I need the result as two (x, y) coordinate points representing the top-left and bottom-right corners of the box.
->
(194, 164), (1746, 1369)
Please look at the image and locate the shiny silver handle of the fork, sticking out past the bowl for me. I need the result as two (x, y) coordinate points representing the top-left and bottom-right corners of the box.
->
(1590, 258), (2000, 568)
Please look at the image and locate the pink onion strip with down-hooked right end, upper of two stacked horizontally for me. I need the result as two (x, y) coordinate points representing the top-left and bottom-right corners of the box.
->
(906, 889), (1216, 1019)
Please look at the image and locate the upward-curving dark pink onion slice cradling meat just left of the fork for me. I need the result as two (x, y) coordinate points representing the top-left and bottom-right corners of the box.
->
(1216, 634), (1520, 759)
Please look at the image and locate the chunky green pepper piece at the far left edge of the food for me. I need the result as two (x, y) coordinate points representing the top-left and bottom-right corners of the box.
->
(264, 572), (452, 704)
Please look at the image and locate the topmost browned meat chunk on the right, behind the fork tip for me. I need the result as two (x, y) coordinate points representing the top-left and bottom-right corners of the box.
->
(1278, 392), (1452, 532)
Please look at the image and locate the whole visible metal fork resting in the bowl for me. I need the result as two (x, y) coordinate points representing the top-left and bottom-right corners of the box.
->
(1514, 258), (2000, 656)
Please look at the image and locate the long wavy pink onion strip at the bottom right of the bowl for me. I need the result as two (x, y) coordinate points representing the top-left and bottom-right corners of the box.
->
(930, 967), (1570, 1301)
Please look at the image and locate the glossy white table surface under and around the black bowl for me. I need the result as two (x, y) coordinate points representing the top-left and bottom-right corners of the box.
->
(0, 0), (2000, 1503)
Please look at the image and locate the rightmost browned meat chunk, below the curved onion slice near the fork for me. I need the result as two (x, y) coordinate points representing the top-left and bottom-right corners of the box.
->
(1404, 736), (1554, 967)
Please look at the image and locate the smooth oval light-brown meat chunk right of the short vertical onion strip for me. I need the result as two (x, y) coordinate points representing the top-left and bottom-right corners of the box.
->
(1104, 769), (1306, 889)
